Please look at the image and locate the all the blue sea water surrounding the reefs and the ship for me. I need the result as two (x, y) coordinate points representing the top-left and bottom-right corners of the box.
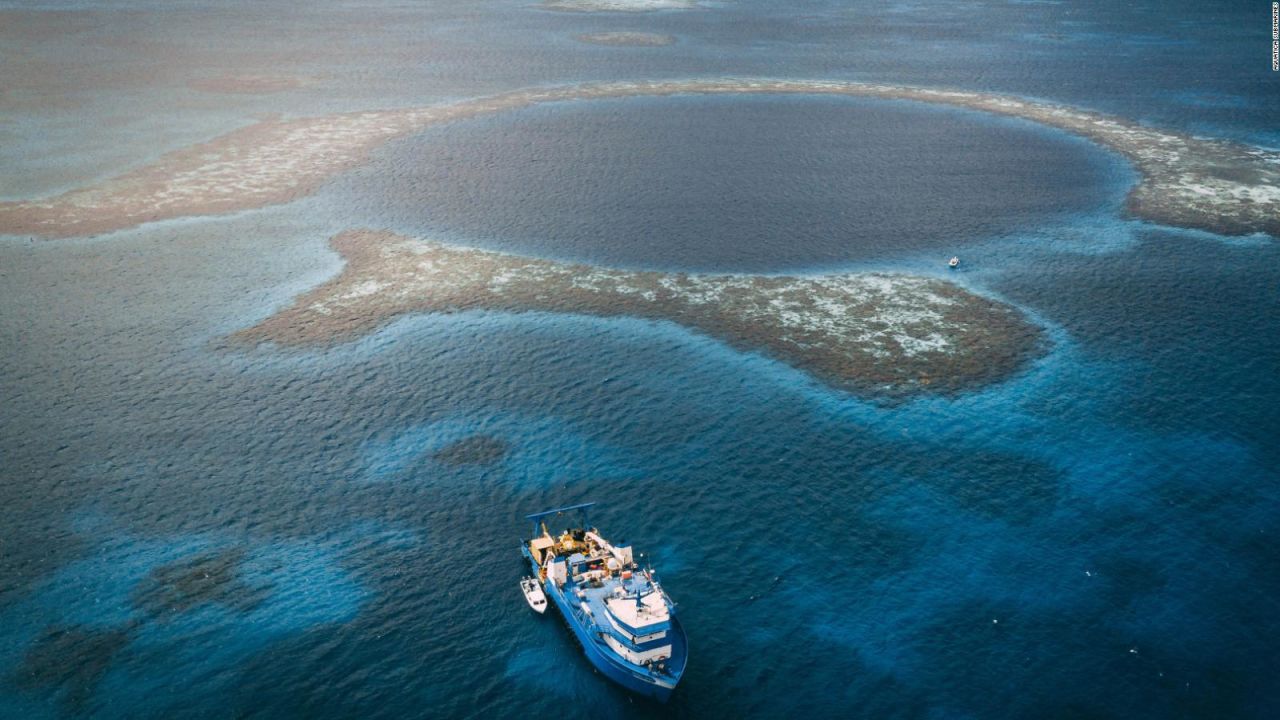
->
(0, 0), (1280, 719)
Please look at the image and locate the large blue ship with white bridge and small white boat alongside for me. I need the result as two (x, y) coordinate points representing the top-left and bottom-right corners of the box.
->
(520, 502), (687, 702)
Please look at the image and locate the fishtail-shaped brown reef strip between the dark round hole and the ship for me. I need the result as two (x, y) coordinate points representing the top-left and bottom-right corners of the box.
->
(230, 231), (1044, 397)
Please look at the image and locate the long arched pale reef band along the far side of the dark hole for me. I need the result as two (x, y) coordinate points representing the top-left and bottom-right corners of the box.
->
(0, 78), (1280, 238)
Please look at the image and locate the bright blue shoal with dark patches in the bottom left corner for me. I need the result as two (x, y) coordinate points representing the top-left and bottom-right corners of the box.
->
(0, 523), (373, 717)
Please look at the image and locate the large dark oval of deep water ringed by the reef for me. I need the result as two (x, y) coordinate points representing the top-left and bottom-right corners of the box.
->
(322, 96), (1128, 272)
